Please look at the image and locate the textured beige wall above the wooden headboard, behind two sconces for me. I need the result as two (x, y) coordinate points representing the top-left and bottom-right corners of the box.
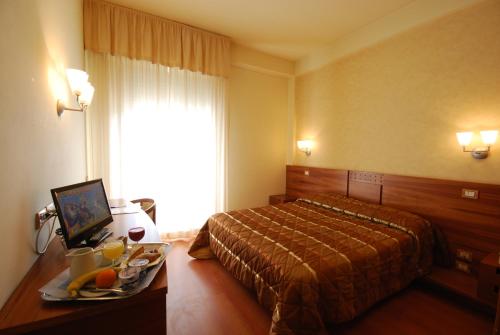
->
(294, 0), (500, 184)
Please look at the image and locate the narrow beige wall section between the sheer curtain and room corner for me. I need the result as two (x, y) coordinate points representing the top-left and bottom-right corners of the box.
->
(227, 45), (293, 209)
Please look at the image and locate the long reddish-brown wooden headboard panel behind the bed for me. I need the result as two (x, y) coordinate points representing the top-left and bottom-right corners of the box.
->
(286, 165), (500, 273)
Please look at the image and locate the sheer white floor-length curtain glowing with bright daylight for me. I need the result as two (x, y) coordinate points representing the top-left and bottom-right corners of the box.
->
(85, 51), (226, 239)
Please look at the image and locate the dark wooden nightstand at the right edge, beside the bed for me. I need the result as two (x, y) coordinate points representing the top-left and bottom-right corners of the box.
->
(477, 252), (500, 306)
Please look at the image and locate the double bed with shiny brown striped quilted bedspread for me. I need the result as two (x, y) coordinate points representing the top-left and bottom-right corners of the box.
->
(189, 194), (433, 334)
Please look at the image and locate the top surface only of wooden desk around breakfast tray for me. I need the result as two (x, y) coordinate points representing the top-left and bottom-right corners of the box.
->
(0, 211), (168, 334)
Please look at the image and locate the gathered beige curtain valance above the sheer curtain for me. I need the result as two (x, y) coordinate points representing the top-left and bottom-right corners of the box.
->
(83, 0), (231, 77)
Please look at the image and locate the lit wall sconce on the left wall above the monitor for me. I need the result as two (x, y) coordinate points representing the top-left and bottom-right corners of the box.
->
(57, 69), (94, 116)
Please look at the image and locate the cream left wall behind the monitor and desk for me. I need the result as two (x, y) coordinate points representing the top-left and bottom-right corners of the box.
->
(0, 0), (85, 305)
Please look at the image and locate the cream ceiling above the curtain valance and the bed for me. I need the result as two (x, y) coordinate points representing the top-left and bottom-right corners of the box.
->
(110, 0), (415, 60)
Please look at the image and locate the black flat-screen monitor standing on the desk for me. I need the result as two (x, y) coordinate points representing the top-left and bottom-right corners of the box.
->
(51, 179), (113, 249)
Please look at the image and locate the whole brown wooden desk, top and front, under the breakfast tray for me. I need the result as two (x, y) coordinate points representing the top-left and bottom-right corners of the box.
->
(0, 211), (168, 335)
